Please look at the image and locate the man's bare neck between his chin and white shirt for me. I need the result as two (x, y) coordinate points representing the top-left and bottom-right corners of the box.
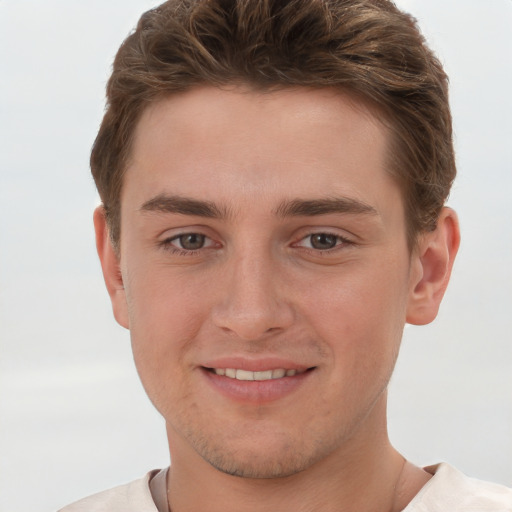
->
(167, 401), (428, 512)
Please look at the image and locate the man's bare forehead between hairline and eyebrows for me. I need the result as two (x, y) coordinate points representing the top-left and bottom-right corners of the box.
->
(122, 87), (400, 220)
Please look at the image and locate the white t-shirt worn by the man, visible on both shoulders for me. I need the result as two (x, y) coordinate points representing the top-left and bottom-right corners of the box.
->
(58, 463), (512, 512)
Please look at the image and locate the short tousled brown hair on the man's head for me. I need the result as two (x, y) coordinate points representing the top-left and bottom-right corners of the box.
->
(91, 0), (455, 246)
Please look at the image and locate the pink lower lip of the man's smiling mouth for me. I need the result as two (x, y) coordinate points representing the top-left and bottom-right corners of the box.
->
(201, 368), (314, 404)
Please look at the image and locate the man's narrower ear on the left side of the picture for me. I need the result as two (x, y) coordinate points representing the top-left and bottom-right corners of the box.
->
(94, 206), (129, 329)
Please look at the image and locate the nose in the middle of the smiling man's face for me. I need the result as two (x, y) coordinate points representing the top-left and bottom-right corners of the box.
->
(212, 249), (294, 341)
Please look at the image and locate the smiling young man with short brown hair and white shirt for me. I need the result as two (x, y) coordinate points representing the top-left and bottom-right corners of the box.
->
(58, 0), (512, 512)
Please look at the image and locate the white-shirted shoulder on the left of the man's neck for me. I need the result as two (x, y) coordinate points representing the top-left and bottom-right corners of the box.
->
(58, 470), (158, 512)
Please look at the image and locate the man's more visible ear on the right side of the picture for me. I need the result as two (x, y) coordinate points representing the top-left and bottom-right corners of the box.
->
(406, 207), (460, 325)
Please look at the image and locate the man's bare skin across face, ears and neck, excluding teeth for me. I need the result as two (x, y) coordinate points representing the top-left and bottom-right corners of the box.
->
(95, 87), (459, 512)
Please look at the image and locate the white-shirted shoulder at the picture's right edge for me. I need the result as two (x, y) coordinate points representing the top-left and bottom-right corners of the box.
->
(403, 464), (512, 512)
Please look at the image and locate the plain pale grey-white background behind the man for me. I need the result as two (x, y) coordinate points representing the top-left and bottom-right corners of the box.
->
(0, 0), (512, 512)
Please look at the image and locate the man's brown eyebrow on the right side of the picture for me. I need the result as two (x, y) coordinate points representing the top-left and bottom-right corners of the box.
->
(275, 197), (378, 217)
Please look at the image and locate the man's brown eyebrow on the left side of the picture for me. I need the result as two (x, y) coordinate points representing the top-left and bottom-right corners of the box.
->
(140, 194), (229, 219)
